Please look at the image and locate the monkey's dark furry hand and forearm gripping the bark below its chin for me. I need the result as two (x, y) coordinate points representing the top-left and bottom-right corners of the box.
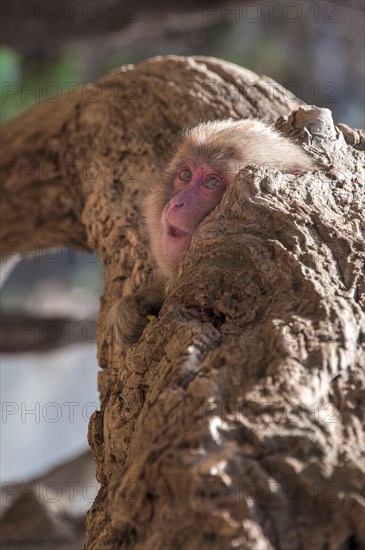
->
(108, 281), (164, 346)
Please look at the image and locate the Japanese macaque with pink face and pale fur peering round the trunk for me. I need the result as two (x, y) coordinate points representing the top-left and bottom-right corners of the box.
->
(113, 119), (316, 344)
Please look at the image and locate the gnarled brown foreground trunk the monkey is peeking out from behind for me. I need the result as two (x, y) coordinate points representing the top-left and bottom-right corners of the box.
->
(88, 105), (365, 550)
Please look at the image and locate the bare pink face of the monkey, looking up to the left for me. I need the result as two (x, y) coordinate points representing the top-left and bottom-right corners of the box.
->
(161, 162), (228, 263)
